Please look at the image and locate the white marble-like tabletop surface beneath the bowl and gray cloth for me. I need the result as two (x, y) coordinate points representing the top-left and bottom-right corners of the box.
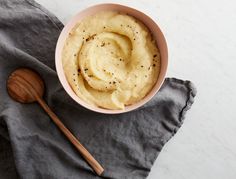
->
(36, 0), (236, 179)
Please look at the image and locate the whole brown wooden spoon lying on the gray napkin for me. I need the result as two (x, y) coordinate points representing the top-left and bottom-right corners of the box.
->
(7, 68), (104, 175)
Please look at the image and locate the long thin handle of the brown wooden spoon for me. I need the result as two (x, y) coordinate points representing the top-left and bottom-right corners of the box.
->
(37, 97), (104, 176)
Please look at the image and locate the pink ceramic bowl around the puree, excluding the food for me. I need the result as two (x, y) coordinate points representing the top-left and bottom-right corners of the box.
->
(55, 4), (168, 114)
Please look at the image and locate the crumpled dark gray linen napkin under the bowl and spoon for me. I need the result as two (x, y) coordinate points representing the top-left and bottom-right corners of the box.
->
(0, 0), (196, 179)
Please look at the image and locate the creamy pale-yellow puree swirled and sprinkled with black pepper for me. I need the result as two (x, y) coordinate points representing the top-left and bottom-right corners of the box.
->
(62, 11), (160, 109)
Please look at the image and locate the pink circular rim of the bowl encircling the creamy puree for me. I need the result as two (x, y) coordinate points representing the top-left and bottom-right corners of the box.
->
(55, 3), (168, 114)
